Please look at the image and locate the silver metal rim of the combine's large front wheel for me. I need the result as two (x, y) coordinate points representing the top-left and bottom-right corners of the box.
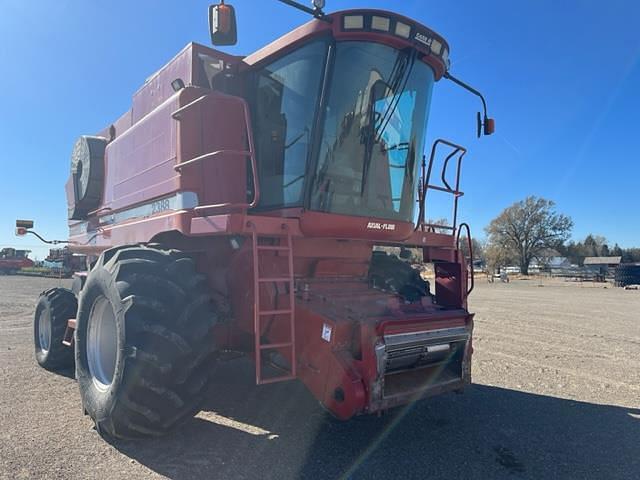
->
(87, 297), (118, 391)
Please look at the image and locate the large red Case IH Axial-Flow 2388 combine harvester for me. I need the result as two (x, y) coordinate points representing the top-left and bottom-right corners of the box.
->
(20, 0), (494, 438)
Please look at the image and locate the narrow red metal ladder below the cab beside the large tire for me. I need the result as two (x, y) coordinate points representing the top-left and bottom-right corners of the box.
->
(252, 224), (296, 385)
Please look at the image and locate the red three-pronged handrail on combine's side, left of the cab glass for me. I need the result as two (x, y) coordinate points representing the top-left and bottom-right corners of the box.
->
(171, 94), (260, 211)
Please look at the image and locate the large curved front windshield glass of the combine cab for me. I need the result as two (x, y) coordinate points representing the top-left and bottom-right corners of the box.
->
(310, 41), (434, 222)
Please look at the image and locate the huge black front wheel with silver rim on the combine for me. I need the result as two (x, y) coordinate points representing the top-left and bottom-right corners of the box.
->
(75, 246), (215, 438)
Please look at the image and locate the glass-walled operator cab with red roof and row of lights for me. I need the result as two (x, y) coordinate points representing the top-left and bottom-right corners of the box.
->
(210, 2), (493, 239)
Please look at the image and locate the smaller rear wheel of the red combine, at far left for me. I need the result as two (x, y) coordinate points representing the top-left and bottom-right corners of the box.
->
(33, 288), (78, 371)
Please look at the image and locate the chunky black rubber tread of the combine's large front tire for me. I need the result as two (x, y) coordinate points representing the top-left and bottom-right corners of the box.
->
(77, 246), (216, 438)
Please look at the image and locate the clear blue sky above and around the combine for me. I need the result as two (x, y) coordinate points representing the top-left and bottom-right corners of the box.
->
(0, 0), (640, 257)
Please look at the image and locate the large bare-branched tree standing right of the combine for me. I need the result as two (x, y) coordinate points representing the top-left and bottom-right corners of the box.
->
(486, 196), (573, 275)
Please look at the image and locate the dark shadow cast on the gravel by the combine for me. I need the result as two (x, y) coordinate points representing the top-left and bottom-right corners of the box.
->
(113, 360), (640, 479)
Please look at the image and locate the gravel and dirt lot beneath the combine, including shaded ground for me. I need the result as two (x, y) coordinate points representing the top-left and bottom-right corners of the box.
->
(0, 277), (640, 479)
